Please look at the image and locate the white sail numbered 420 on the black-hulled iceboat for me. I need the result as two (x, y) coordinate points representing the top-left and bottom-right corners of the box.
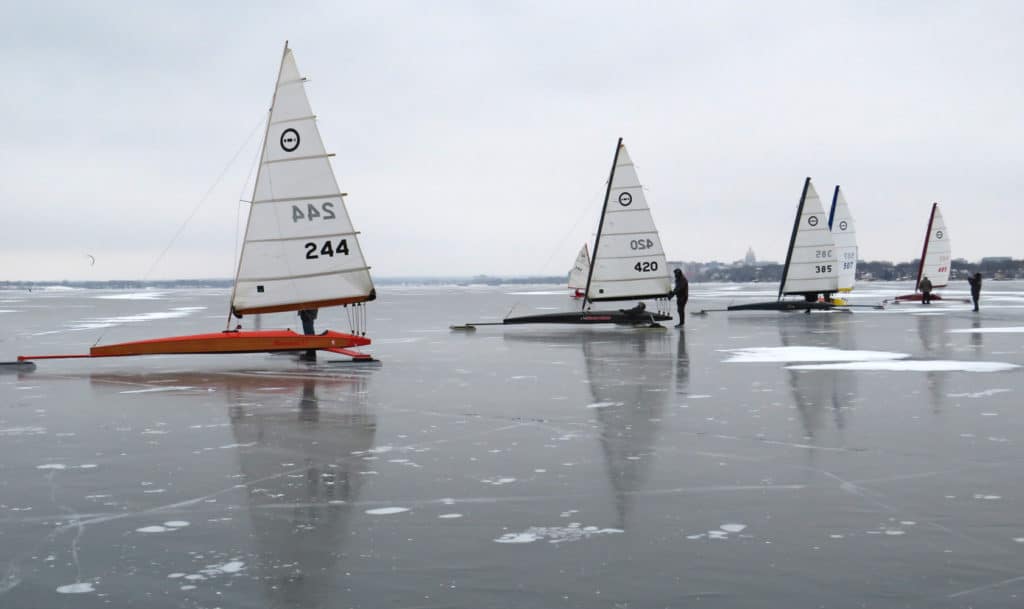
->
(587, 139), (672, 302)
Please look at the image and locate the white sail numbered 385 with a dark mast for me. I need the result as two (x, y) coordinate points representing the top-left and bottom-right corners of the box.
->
(779, 178), (839, 295)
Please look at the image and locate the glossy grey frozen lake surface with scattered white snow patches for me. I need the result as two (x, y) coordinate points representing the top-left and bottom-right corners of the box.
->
(0, 281), (1024, 609)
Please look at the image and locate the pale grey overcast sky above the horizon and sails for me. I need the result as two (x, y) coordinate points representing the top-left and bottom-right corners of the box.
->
(0, 0), (1024, 279)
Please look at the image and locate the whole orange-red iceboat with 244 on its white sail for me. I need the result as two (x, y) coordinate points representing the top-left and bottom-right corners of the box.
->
(18, 42), (376, 362)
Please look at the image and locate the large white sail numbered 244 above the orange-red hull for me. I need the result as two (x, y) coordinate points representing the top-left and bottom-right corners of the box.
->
(231, 45), (374, 314)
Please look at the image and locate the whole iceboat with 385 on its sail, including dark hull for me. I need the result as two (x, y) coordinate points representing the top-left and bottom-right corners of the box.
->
(720, 178), (839, 314)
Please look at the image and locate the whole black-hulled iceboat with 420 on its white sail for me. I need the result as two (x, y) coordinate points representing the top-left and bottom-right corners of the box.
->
(452, 137), (672, 330)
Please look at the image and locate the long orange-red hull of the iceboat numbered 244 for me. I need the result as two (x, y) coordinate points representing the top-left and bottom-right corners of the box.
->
(17, 330), (371, 361)
